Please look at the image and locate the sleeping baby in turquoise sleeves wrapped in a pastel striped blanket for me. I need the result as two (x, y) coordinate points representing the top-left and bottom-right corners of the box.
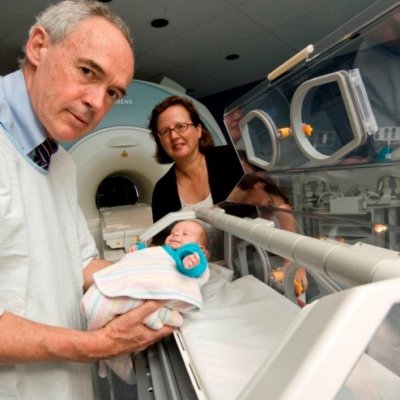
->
(81, 220), (210, 383)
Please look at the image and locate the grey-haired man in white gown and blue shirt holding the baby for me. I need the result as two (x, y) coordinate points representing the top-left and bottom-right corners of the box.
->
(0, 0), (172, 400)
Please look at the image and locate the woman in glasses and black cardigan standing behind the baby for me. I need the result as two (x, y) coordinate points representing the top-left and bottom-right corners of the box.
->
(149, 96), (243, 222)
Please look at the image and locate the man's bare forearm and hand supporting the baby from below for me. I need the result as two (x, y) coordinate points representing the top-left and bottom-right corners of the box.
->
(0, 300), (174, 365)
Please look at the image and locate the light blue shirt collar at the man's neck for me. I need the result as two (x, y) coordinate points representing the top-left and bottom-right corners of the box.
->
(0, 70), (47, 154)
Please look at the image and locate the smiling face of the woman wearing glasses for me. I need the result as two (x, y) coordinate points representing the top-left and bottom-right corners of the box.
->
(157, 105), (201, 161)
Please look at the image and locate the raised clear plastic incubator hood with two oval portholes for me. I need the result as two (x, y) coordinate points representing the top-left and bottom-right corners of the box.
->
(224, 1), (400, 250)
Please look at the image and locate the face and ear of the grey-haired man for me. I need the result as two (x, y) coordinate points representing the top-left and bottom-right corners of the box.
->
(25, 17), (134, 141)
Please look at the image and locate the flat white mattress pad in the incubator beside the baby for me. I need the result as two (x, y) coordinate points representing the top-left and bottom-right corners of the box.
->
(176, 268), (300, 400)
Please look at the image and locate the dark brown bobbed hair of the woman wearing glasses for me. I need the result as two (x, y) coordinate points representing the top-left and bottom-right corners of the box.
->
(149, 96), (214, 164)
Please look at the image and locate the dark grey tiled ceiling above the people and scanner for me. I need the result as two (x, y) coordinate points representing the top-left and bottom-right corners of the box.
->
(0, 0), (396, 97)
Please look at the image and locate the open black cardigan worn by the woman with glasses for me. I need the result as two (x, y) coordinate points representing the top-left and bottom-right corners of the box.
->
(151, 145), (244, 222)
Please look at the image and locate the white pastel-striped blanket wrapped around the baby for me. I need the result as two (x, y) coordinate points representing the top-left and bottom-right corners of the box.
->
(81, 246), (209, 383)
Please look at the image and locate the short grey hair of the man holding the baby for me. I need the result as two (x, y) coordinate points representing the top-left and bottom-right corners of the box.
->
(19, 0), (133, 67)
